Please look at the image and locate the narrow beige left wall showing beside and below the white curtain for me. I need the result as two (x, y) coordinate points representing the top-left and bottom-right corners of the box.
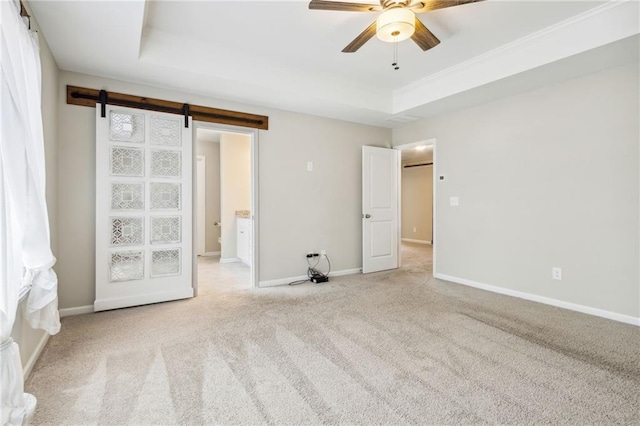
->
(11, 5), (59, 369)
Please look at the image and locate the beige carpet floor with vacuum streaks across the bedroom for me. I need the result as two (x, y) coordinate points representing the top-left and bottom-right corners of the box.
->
(26, 246), (640, 425)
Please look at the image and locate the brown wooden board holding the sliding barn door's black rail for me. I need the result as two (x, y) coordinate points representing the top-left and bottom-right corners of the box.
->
(67, 86), (269, 130)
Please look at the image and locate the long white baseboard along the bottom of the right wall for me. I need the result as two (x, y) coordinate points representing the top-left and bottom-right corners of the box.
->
(433, 273), (640, 326)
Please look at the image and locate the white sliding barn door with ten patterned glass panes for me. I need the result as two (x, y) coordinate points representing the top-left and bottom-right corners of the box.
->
(94, 105), (193, 311)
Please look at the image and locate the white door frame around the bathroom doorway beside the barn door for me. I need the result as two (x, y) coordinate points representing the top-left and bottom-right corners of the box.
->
(192, 120), (260, 296)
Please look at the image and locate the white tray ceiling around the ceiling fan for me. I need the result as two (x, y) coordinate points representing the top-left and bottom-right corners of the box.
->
(28, 0), (639, 127)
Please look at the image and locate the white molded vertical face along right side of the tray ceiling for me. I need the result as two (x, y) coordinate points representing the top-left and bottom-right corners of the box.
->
(392, 0), (640, 114)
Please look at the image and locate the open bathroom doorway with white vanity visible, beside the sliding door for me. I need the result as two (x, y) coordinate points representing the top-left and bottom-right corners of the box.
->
(193, 122), (258, 295)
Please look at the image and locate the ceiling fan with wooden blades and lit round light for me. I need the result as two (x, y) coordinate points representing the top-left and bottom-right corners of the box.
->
(309, 0), (483, 53)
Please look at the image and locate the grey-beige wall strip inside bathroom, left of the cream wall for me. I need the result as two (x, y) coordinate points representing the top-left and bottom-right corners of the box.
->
(196, 137), (221, 252)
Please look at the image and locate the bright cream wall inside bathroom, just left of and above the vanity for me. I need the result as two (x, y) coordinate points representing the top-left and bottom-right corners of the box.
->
(220, 133), (251, 260)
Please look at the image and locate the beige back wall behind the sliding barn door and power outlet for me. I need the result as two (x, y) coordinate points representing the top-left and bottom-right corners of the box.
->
(53, 71), (391, 308)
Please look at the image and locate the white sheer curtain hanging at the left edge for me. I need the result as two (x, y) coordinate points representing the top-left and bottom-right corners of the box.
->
(0, 0), (60, 425)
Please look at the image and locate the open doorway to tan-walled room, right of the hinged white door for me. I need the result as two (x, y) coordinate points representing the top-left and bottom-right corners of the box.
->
(395, 139), (436, 275)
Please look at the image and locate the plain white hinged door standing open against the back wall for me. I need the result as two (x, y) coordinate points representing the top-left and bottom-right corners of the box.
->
(362, 146), (400, 274)
